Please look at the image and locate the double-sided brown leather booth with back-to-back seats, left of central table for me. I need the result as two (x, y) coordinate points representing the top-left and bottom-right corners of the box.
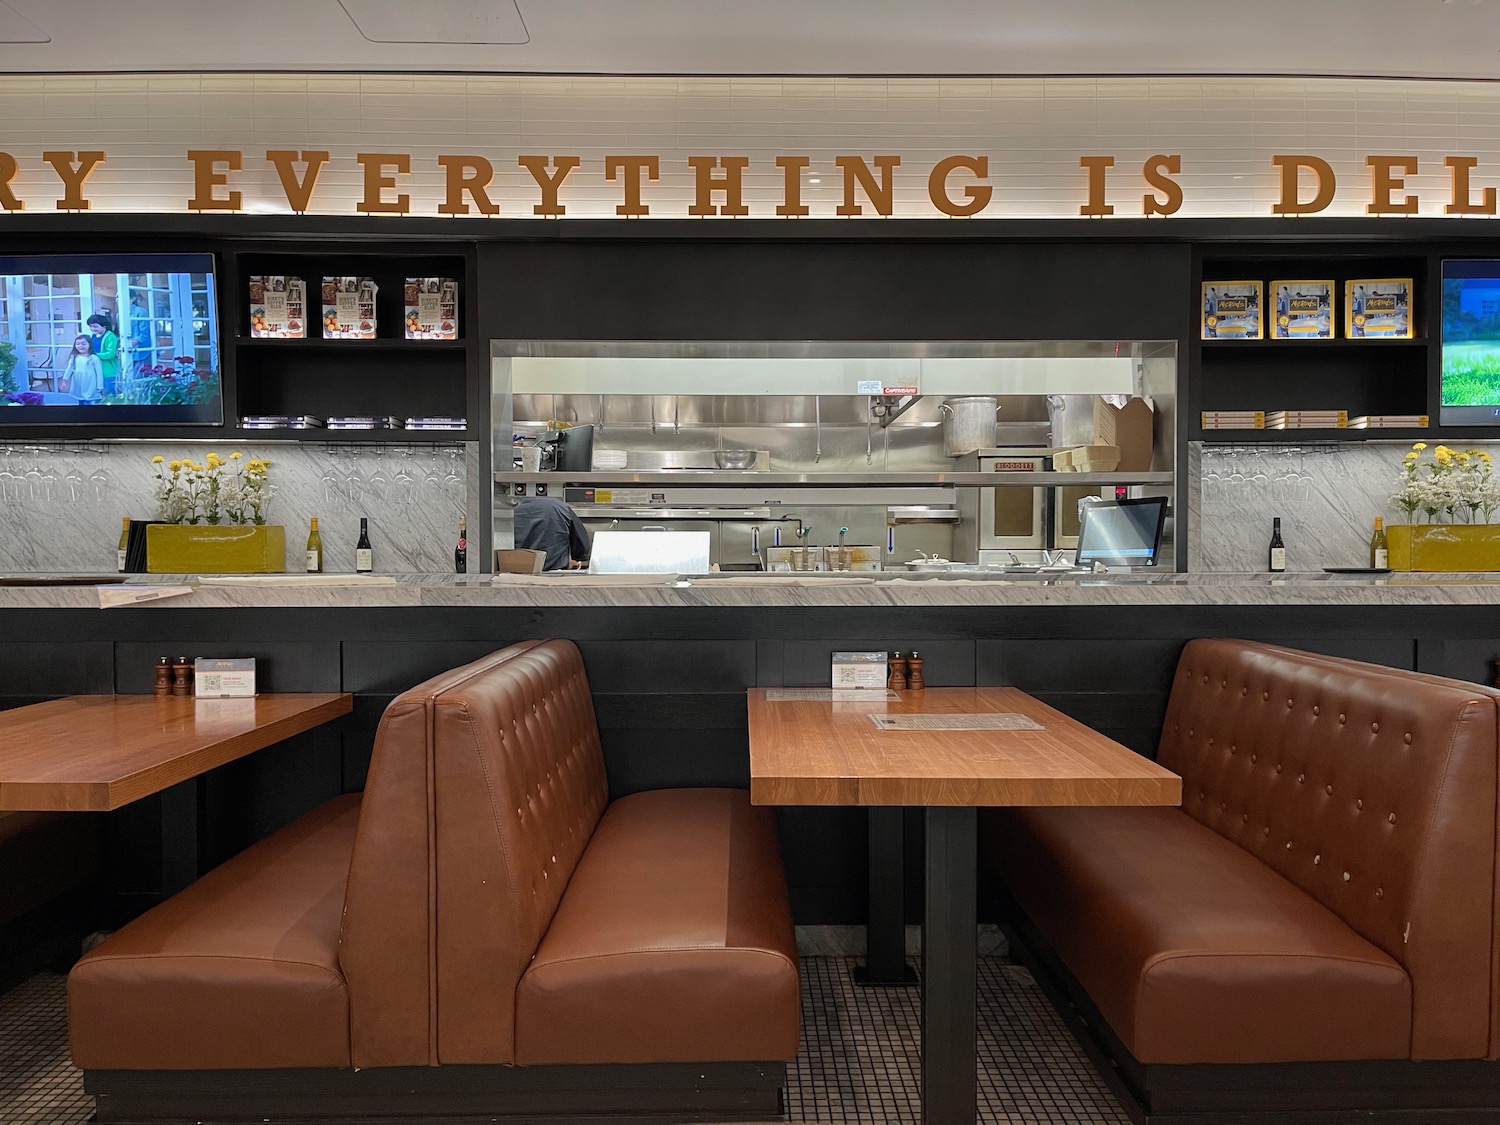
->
(68, 641), (800, 1122)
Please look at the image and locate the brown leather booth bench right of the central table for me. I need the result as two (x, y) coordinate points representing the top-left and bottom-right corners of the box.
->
(983, 639), (1500, 1122)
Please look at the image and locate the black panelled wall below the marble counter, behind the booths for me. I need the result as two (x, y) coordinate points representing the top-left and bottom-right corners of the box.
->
(11, 605), (1500, 923)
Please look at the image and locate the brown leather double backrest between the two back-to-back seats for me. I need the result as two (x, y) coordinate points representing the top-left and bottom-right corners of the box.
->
(341, 641), (608, 1067)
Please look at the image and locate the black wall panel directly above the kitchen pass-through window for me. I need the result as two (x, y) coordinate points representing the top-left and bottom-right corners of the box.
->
(480, 238), (1193, 341)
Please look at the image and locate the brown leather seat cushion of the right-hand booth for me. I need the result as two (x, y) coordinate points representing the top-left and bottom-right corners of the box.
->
(986, 809), (1412, 1064)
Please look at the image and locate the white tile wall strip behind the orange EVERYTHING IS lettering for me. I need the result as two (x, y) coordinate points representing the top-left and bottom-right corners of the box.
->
(0, 74), (1500, 221)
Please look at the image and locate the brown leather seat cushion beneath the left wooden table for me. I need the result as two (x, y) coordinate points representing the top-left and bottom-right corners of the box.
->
(68, 794), (360, 1070)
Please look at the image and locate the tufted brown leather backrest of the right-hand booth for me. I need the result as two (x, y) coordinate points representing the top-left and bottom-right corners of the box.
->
(1158, 639), (1500, 1059)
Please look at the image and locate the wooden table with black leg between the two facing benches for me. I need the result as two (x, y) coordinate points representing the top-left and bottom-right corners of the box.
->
(749, 687), (1182, 1125)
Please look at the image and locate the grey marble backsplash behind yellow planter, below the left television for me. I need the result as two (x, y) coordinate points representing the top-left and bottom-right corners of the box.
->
(0, 443), (480, 573)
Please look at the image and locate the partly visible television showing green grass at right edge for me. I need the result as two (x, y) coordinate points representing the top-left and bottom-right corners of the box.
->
(1439, 260), (1500, 426)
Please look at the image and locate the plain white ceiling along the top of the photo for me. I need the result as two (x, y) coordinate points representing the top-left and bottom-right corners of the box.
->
(0, 0), (1500, 80)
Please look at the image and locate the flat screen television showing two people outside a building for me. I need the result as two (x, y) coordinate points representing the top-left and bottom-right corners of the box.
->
(0, 254), (224, 426)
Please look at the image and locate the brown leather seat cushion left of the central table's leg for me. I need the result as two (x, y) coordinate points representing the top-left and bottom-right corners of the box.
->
(516, 789), (798, 1065)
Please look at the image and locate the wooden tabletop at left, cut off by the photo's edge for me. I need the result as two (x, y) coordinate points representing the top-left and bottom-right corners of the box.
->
(0, 693), (354, 812)
